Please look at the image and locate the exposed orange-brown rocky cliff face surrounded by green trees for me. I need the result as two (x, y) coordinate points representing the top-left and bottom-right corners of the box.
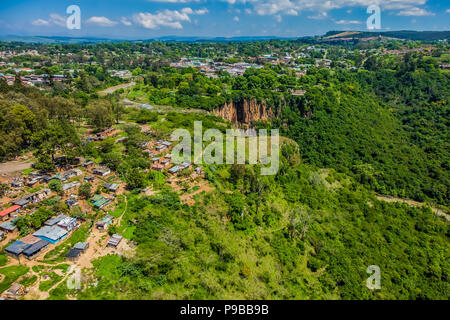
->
(213, 99), (274, 126)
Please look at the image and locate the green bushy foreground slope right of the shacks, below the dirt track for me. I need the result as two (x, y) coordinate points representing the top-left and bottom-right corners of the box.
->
(75, 147), (449, 299)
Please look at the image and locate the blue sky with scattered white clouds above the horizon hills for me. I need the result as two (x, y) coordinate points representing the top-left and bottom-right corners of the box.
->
(0, 0), (450, 39)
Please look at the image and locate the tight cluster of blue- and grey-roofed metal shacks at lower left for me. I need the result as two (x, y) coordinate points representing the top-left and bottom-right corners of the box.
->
(5, 214), (79, 260)
